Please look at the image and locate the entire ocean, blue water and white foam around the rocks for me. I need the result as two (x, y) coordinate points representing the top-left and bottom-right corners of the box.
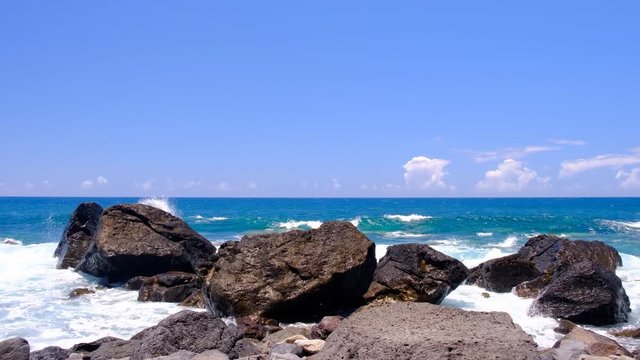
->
(0, 197), (640, 350)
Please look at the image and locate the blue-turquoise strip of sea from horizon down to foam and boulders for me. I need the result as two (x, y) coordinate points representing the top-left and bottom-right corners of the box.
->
(0, 197), (640, 256)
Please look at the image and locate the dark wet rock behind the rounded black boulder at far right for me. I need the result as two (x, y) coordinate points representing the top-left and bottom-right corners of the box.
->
(467, 235), (622, 297)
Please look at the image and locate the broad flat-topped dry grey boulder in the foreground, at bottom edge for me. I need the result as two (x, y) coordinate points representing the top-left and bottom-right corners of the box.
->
(311, 302), (538, 360)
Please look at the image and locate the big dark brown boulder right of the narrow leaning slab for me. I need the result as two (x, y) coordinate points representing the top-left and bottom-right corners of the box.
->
(77, 204), (216, 281)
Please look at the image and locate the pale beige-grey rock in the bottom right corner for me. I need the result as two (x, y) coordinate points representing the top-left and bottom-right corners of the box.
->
(540, 326), (631, 360)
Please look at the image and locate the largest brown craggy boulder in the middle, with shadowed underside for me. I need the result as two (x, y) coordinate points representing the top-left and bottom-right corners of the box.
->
(207, 222), (376, 320)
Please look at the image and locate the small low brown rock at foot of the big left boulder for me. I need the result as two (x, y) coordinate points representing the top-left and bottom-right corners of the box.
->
(124, 271), (203, 302)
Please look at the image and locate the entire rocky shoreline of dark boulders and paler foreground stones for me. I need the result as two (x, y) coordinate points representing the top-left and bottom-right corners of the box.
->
(0, 203), (640, 360)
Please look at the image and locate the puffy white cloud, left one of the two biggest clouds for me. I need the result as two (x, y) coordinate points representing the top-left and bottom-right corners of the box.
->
(403, 156), (449, 189)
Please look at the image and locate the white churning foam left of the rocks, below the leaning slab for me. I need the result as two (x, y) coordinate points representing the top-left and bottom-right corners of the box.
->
(0, 243), (183, 350)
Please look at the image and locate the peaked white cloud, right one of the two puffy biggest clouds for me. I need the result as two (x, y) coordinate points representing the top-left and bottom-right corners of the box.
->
(476, 159), (549, 192)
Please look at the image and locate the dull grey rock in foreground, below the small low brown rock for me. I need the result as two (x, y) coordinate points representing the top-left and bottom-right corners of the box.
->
(131, 310), (242, 360)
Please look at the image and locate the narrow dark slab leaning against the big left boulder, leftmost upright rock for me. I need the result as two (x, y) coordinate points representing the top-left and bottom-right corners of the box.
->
(53, 202), (103, 269)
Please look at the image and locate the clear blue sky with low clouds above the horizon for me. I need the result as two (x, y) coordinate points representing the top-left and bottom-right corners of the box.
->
(0, 0), (640, 197)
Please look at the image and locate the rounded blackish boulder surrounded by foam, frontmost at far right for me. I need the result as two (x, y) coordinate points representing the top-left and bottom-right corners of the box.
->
(529, 261), (631, 325)
